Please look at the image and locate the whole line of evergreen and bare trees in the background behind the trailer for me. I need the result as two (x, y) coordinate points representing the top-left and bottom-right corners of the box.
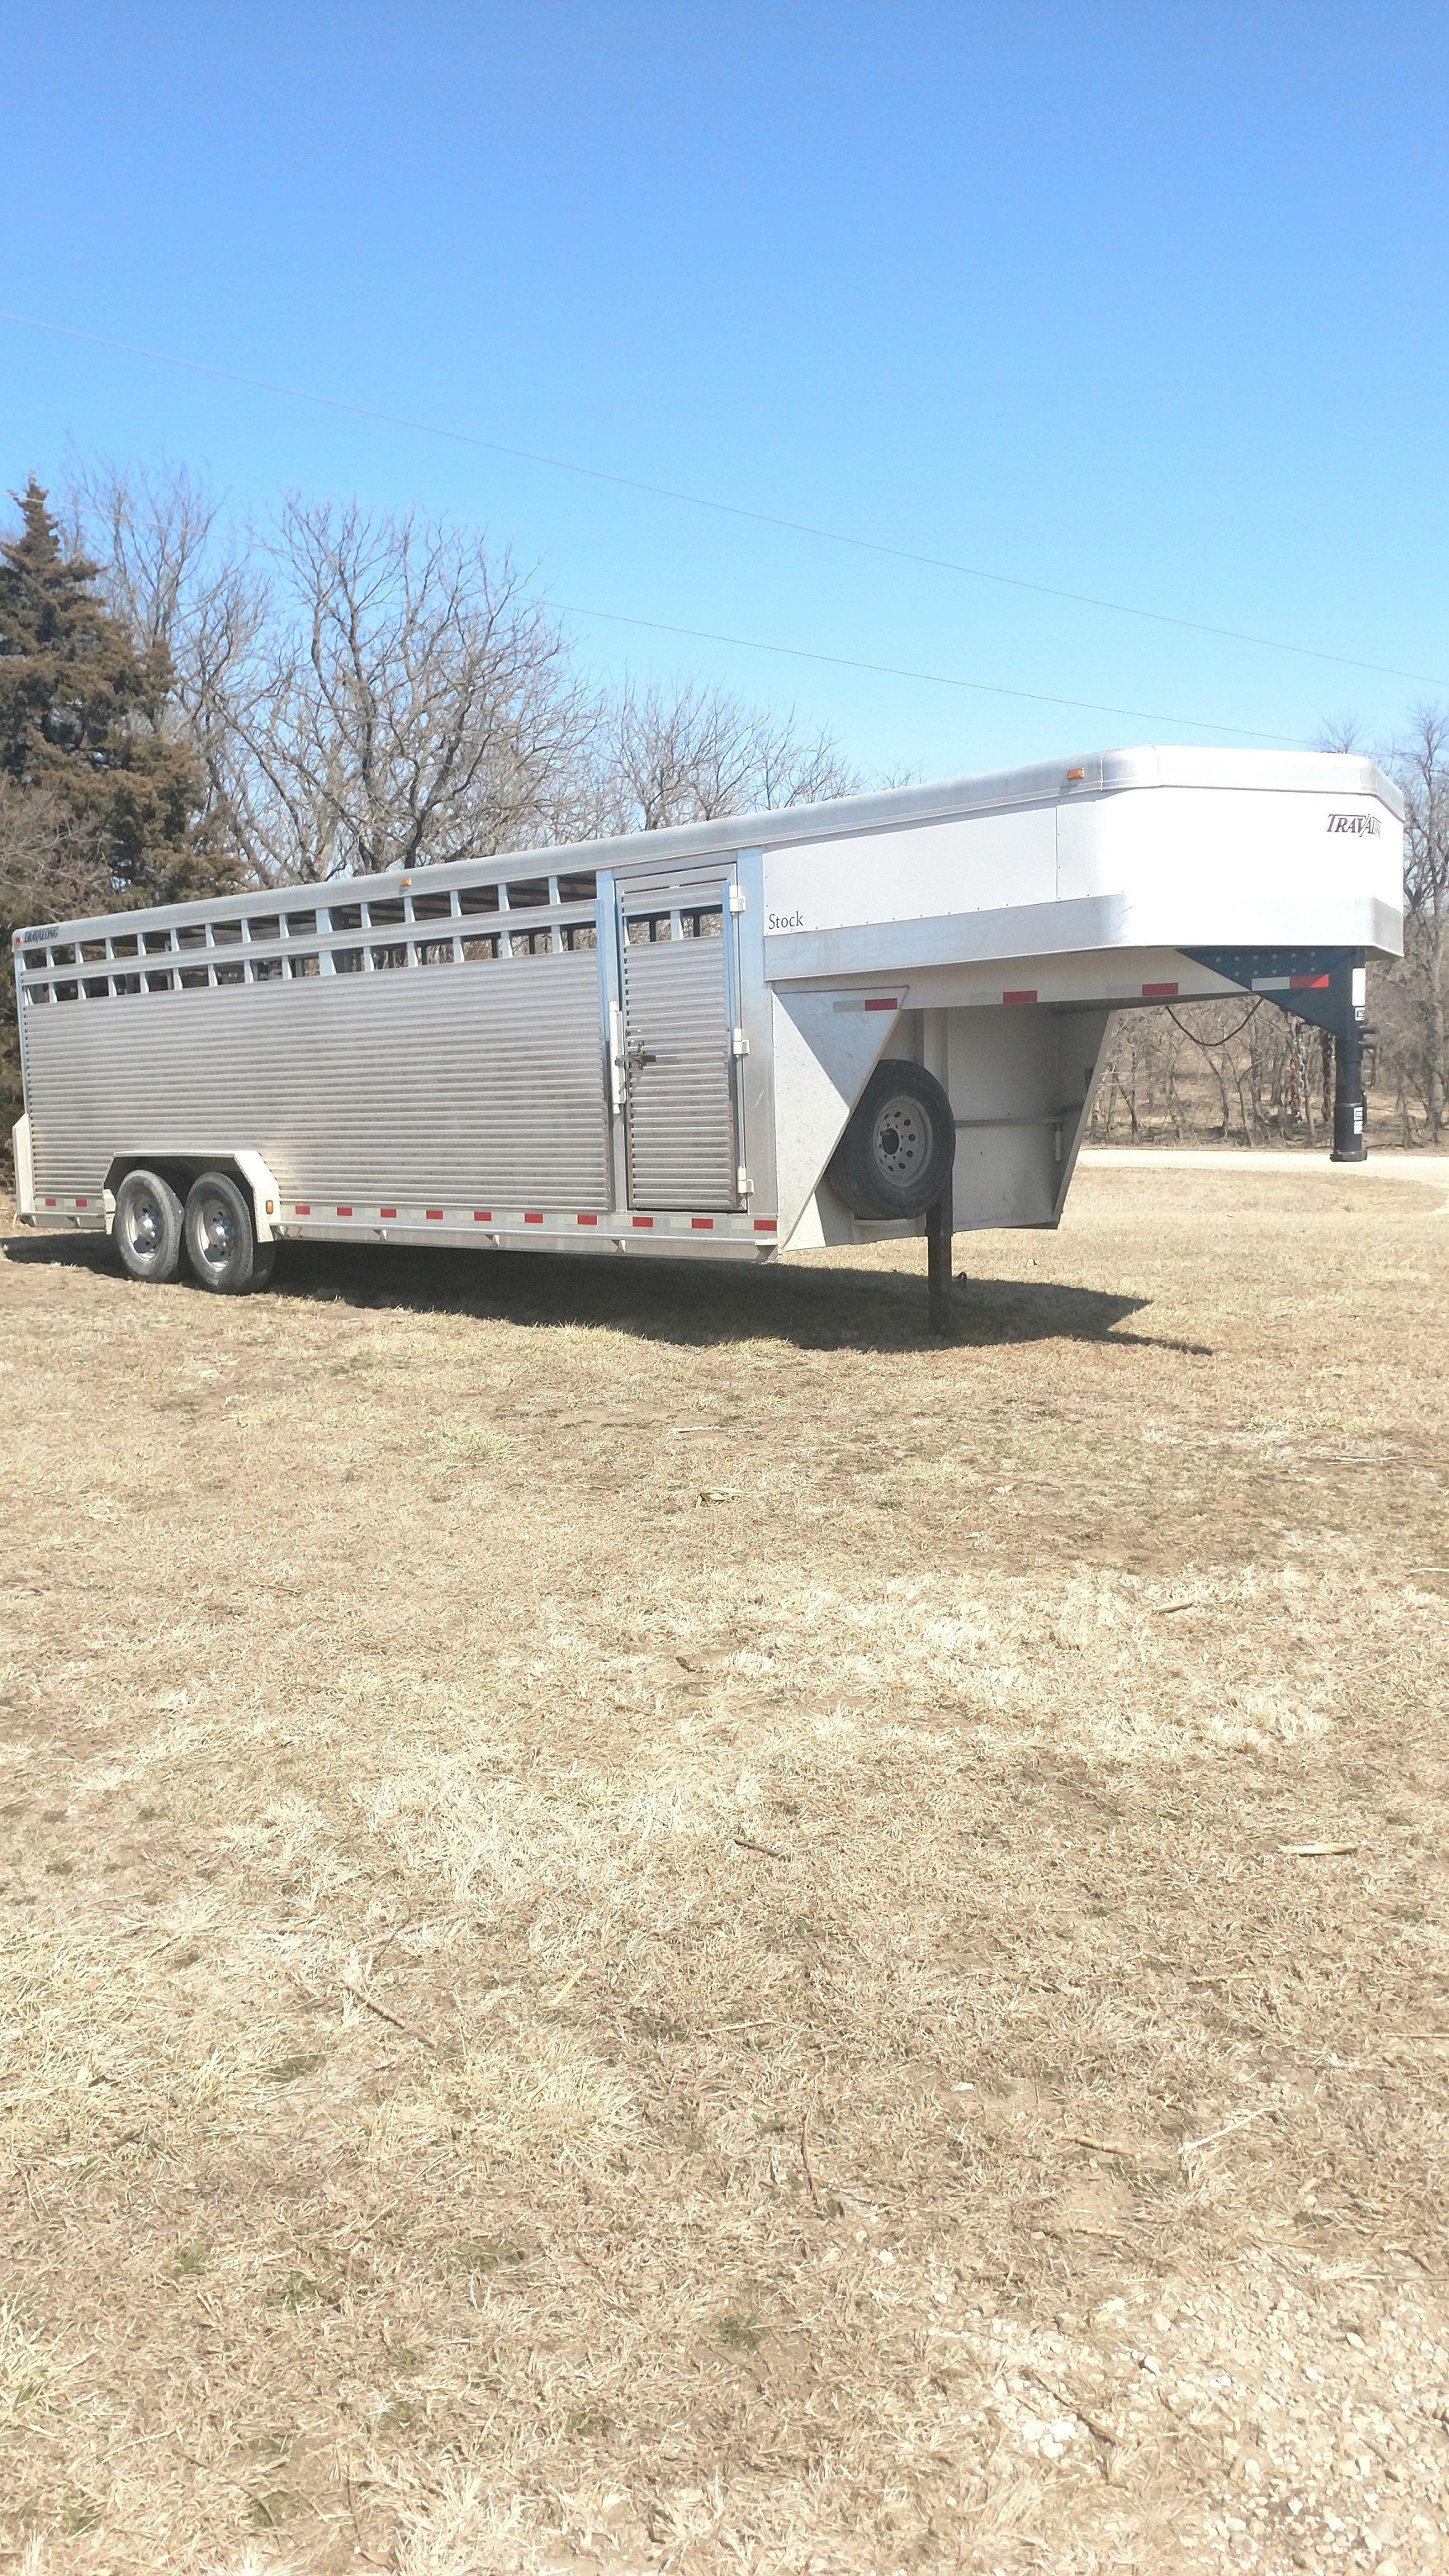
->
(0, 466), (1449, 1144)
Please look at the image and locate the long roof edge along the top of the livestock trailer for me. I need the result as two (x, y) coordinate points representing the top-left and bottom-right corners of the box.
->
(16, 742), (1403, 943)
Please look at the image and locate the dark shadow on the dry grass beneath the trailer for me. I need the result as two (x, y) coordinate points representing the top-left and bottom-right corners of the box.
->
(2, 1237), (1212, 1357)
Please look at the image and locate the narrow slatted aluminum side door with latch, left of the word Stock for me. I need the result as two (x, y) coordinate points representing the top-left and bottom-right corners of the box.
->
(618, 865), (740, 1210)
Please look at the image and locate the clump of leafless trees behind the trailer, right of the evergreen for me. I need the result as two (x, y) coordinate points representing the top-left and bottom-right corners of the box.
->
(69, 466), (856, 883)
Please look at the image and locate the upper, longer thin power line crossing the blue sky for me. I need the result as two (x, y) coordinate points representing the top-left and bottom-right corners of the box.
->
(0, 309), (1449, 695)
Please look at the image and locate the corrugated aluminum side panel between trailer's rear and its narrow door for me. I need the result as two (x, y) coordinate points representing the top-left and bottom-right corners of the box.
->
(26, 950), (611, 1210)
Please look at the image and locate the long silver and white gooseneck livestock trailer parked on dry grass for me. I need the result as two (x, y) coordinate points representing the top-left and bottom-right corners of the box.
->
(16, 747), (1403, 1329)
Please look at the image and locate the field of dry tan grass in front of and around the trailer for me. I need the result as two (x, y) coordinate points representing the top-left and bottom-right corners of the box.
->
(0, 1162), (1449, 2576)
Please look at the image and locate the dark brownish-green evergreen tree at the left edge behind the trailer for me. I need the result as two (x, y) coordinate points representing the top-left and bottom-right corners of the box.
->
(0, 476), (234, 907)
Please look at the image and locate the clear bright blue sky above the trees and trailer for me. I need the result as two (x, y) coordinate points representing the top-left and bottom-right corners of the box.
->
(0, 0), (1449, 775)
